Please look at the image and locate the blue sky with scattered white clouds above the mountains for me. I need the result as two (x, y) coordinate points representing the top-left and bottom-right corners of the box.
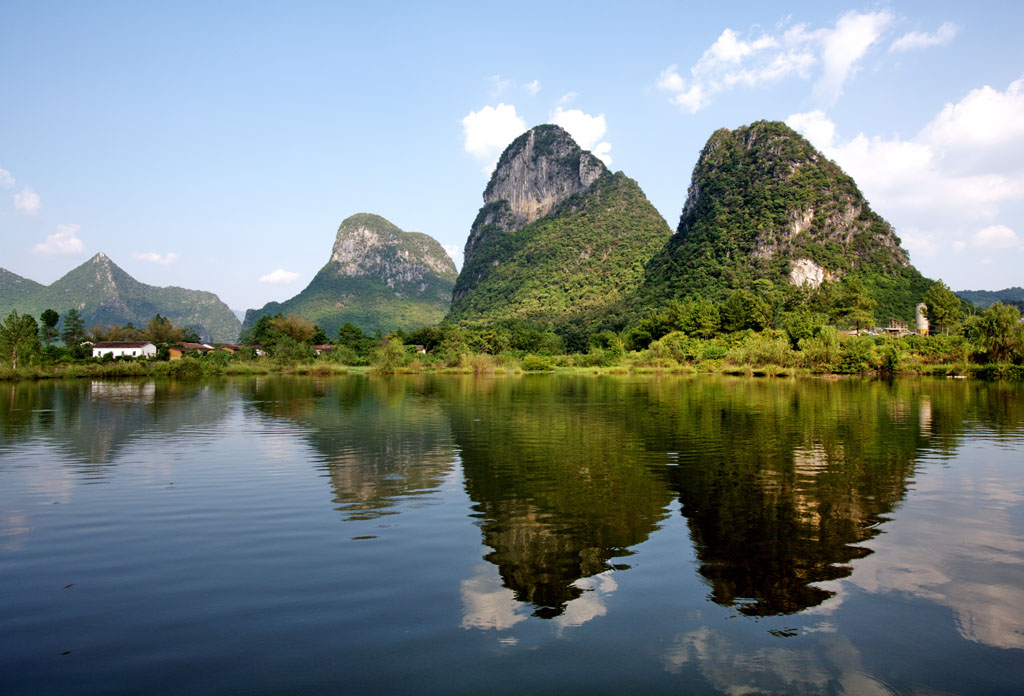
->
(0, 0), (1024, 309)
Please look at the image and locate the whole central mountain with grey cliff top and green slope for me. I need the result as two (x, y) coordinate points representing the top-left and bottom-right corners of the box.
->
(449, 125), (671, 324)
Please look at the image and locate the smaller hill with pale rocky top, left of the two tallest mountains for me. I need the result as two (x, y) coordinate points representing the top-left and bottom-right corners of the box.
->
(244, 213), (457, 337)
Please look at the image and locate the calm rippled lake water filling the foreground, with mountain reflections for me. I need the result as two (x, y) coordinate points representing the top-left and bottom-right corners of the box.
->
(0, 376), (1024, 696)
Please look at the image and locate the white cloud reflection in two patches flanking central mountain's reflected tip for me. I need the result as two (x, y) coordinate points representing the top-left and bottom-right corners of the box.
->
(460, 564), (618, 636)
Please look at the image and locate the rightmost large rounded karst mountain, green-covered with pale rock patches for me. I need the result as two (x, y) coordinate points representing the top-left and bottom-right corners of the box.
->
(641, 121), (931, 318)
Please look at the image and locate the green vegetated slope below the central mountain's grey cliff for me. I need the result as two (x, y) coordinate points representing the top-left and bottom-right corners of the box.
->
(447, 173), (671, 327)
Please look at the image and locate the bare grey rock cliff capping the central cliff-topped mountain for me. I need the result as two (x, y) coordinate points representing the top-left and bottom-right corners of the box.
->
(483, 125), (608, 227)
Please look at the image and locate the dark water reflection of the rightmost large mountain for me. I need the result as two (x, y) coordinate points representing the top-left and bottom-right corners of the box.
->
(639, 380), (963, 615)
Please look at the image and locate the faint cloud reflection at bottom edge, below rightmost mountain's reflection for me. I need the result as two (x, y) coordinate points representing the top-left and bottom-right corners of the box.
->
(665, 626), (892, 696)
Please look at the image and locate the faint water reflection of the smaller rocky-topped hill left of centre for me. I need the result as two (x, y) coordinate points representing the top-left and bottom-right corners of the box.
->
(243, 376), (455, 520)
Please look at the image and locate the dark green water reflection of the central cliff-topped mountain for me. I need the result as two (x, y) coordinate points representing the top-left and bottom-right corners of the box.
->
(447, 378), (671, 618)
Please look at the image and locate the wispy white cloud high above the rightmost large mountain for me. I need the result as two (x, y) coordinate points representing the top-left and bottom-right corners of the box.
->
(654, 10), (894, 114)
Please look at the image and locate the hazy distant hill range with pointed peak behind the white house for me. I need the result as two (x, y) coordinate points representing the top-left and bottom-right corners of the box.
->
(0, 253), (242, 342)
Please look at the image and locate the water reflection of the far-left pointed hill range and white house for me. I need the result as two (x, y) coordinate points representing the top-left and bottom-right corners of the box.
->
(0, 380), (230, 478)
